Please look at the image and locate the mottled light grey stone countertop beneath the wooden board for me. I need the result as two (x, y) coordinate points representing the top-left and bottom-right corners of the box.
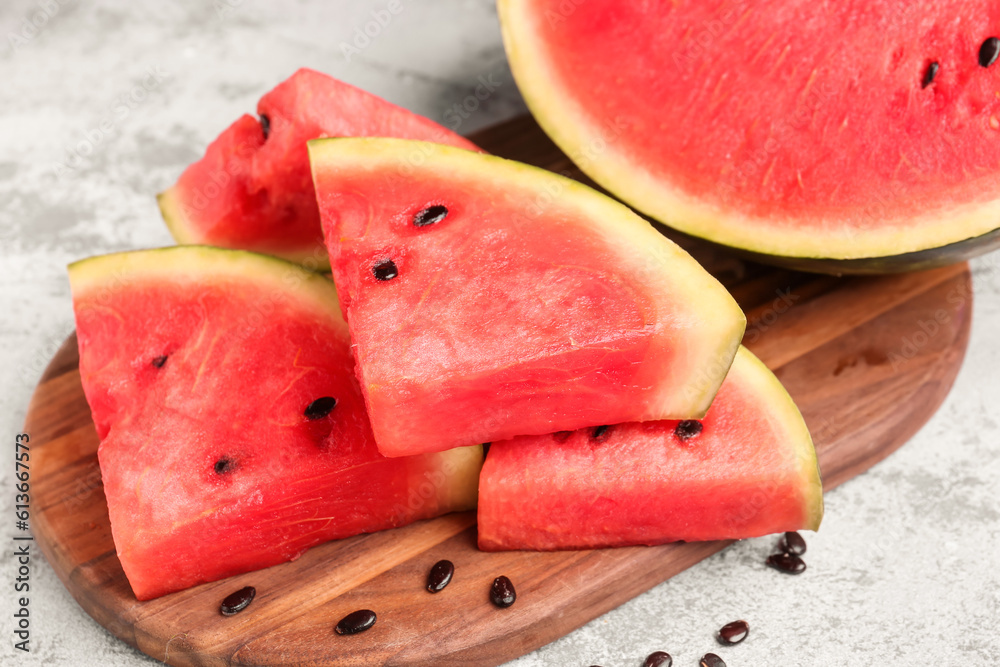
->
(0, 0), (1000, 667)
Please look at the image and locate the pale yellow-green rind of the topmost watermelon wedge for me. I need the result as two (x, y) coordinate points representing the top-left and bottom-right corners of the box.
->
(308, 137), (746, 419)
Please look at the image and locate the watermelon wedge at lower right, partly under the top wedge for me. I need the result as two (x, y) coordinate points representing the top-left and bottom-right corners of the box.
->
(479, 348), (823, 551)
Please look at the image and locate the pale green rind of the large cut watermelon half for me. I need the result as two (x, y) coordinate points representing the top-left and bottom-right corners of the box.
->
(497, 0), (1000, 266)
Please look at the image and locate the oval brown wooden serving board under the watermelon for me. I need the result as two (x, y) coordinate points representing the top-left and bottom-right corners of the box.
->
(25, 118), (972, 667)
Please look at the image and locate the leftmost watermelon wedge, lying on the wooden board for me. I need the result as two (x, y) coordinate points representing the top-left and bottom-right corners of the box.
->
(69, 246), (482, 600)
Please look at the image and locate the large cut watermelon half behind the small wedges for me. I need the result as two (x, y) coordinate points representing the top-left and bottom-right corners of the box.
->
(498, 0), (1000, 272)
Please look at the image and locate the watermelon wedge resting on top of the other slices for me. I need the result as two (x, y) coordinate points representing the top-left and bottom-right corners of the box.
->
(309, 139), (745, 456)
